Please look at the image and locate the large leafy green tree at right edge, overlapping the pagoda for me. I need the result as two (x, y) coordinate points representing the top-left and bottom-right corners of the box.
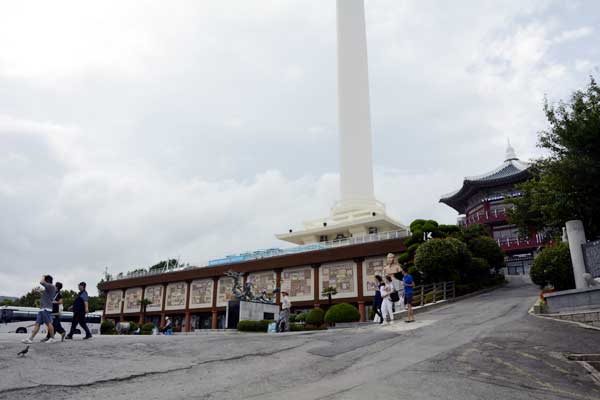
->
(510, 77), (600, 238)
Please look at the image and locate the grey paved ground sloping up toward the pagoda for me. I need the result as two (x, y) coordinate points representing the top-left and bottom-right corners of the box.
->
(0, 283), (600, 400)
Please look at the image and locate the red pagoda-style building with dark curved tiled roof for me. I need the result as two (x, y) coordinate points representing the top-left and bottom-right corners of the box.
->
(440, 143), (543, 275)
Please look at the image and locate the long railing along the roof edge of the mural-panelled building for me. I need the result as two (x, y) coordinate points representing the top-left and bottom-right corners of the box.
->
(111, 231), (408, 281)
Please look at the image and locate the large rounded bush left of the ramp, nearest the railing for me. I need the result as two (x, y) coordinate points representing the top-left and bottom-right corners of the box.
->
(415, 238), (471, 282)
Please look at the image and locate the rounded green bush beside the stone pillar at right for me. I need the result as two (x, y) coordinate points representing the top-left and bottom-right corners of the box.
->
(529, 243), (575, 290)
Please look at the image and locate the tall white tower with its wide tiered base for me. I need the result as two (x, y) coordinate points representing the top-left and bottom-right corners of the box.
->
(276, 0), (408, 244)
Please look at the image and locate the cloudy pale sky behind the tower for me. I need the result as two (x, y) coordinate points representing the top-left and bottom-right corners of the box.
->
(0, 0), (600, 296)
